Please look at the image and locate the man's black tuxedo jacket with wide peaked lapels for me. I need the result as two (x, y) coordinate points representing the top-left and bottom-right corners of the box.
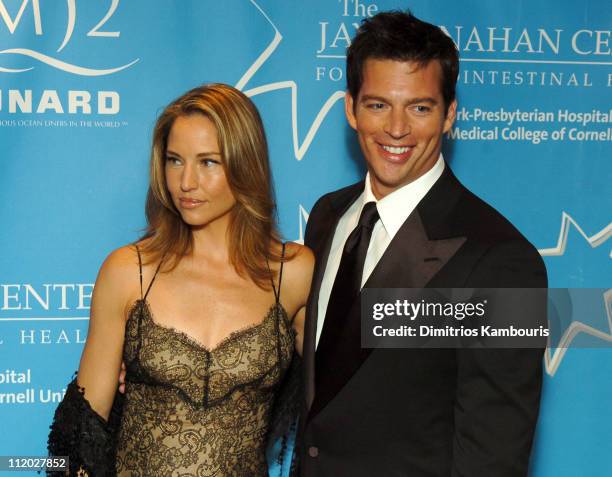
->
(296, 166), (547, 477)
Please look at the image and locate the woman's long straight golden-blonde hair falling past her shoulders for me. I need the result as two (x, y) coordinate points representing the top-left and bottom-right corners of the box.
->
(140, 84), (281, 289)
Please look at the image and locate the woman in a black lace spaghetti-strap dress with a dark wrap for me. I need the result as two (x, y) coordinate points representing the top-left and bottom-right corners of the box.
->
(50, 84), (314, 475)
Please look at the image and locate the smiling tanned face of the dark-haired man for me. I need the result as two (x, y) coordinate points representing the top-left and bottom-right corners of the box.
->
(345, 59), (457, 199)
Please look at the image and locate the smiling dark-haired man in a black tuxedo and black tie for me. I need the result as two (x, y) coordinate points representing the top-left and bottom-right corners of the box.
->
(296, 12), (546, 477)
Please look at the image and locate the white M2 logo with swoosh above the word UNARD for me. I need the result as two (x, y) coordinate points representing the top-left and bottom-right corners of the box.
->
(0, 0), (139, 76)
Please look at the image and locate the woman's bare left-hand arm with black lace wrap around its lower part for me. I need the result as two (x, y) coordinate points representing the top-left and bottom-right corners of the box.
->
(48, 247), (139, 475)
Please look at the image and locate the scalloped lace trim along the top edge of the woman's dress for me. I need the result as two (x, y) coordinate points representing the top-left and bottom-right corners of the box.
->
(128, 298), (293, 355)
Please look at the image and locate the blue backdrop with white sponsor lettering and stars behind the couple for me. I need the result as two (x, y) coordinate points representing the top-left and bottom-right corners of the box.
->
(0, 0), (612, 477)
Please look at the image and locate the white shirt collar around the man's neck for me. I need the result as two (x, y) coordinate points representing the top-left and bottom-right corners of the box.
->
(361, 154), (444, 239)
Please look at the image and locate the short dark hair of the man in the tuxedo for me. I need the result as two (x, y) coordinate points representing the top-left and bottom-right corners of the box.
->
(346, 11), (459, 111)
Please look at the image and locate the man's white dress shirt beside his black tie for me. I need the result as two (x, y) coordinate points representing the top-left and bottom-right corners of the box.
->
(316, 155), (444, 345)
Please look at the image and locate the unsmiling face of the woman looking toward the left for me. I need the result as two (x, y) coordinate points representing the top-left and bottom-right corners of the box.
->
(165, 113), (236, 227)
